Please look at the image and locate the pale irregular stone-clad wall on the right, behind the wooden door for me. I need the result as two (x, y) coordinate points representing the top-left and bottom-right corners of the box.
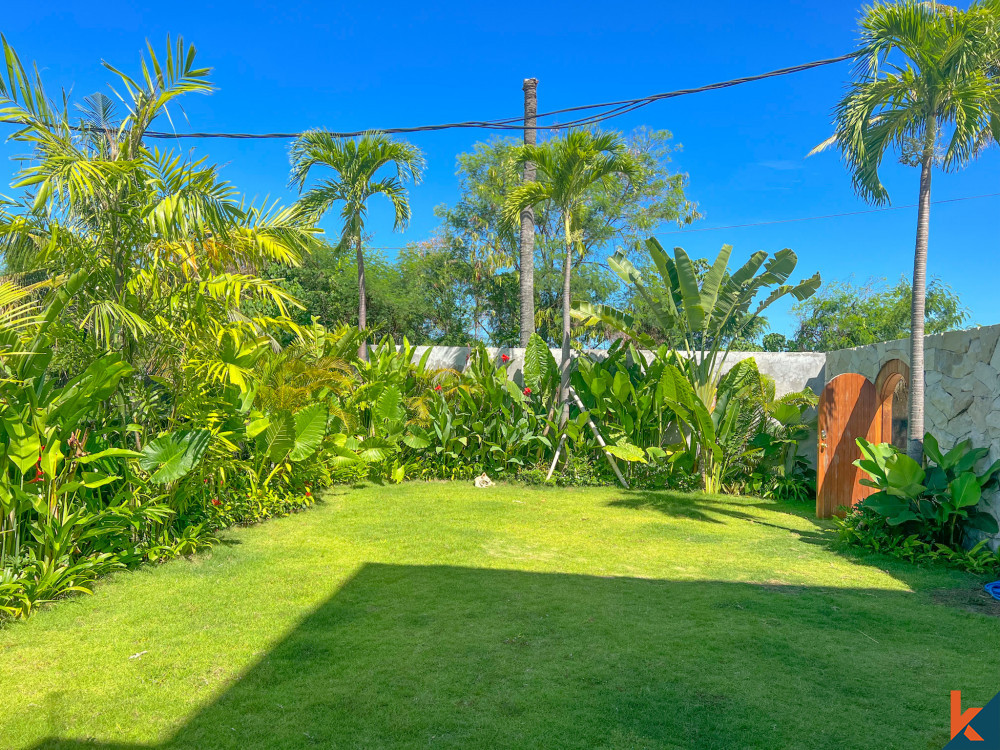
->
(826, 325), (1000, 547)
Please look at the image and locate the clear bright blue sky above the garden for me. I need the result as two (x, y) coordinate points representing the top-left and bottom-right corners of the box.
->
(0, 0), (1000, 332)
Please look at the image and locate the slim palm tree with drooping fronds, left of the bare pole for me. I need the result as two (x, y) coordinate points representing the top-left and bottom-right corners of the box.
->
(291, 130), (424, 358)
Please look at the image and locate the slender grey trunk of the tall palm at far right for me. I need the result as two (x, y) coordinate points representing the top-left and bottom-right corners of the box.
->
(906, 118), (937, 461)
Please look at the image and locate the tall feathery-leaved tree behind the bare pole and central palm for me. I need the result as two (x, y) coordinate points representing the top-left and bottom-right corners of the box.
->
(436, 128), (699, 346)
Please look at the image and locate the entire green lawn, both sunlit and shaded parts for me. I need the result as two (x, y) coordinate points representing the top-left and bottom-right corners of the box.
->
(0, 483), (1000, 750)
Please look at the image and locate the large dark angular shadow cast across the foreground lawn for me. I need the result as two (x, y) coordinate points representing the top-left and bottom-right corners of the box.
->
(25, 564), (1000, 750)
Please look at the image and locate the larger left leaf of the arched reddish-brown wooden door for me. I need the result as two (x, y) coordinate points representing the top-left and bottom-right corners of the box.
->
(816, 373), (882, 518)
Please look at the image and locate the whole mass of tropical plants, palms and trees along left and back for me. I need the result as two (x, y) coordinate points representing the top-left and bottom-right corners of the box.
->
(0, 25), (974, 616)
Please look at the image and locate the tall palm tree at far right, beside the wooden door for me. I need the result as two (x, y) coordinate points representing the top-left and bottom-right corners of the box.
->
(813, 0), (1000, 460)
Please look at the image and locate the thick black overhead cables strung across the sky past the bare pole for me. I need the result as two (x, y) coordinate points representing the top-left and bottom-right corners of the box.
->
(5, 52), (856, 140)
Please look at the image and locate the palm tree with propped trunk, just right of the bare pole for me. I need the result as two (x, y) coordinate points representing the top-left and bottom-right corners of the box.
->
(503, 130), (639, 421)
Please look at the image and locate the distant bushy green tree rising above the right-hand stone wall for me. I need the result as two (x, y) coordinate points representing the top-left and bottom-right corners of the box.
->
(790, 277), (969, 352)
